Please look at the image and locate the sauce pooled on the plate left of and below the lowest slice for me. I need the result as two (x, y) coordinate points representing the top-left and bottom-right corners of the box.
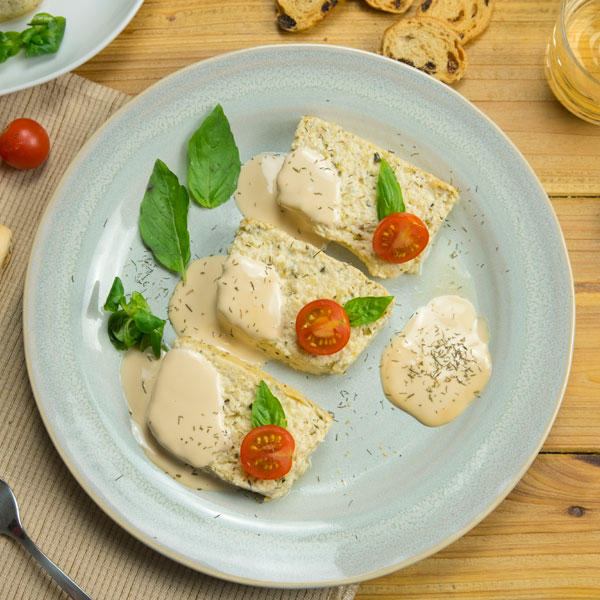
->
(121, 348), (228, 490)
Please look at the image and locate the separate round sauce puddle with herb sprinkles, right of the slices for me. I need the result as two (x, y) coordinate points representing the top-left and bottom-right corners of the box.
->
(380, 296), (492, 427)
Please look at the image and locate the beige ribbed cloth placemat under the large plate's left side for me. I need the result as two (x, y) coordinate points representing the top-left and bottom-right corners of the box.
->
(0, 74), (357, 600)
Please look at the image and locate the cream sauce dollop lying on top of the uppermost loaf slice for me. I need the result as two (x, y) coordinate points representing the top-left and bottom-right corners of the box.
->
(277, 148), (341, 225)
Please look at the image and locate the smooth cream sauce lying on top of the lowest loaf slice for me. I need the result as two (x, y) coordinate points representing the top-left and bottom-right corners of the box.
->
(146, 348), (229, 468)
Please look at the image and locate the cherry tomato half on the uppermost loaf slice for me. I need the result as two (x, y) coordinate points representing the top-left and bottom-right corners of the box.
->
(373, 213), (429, 263)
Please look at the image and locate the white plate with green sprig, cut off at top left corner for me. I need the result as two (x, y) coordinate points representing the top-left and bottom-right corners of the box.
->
(0, 0), (143, 96)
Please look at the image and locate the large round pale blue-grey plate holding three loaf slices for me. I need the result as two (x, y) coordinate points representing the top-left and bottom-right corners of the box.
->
(24, 45), (574, 587)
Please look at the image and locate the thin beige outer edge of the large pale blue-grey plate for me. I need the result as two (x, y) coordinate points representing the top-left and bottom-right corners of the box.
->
(22, 43), (576, 589)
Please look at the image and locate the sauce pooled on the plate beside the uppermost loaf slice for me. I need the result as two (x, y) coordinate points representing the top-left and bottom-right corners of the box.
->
(234, 153), (326, 247)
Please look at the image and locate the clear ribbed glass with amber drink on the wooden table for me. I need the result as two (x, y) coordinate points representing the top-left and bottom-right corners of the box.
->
(546, 0), (600, 125)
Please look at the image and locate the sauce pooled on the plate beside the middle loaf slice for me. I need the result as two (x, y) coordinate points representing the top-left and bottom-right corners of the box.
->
(169, 256), (266, 365)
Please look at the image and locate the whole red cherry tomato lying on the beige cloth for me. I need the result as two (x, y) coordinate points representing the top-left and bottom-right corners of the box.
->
(0, 119), (50, 169)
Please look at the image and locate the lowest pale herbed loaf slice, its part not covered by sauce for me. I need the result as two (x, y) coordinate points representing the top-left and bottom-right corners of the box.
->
(173, 338), (333, 499)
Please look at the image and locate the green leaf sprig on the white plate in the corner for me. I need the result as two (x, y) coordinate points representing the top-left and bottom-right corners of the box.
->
(0, 13), (67, 63)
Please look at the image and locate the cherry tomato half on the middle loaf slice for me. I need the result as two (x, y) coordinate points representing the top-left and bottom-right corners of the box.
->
(296, 299), (350, 354)
